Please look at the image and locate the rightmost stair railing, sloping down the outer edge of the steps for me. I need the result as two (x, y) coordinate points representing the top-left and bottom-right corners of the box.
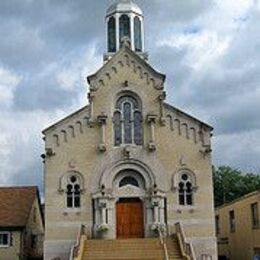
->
(175, 222), (196, 260)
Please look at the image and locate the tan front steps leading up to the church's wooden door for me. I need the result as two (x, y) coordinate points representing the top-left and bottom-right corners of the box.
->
(82, 238), (183, 260)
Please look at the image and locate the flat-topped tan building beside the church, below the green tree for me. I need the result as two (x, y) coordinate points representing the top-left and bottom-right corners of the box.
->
(215, 191), (260, 260)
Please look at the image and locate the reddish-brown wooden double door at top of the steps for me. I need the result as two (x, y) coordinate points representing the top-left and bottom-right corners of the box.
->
(116, 198), (144, 239)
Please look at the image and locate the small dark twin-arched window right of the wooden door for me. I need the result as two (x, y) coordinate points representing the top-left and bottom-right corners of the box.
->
(178, 173), (193, 206)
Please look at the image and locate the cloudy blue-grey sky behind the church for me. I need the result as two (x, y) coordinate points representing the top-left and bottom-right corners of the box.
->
(0, 0), (260, 193)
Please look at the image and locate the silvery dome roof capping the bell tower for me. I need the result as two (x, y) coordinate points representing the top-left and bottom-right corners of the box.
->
(106, 0), (143, 16)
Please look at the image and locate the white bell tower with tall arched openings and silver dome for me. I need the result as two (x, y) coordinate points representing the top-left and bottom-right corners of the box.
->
(104, 0), (147, 60)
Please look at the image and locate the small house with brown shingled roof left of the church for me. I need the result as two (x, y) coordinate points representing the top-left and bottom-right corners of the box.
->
(0, 187), (44, 260)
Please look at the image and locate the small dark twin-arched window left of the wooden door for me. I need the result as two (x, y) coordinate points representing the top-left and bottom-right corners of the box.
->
(66, 175), (81, 208)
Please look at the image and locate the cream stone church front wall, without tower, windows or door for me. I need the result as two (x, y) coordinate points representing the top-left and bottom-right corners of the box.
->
(43, 1), (216, 259)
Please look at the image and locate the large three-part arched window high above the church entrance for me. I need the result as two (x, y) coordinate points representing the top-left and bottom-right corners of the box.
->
(114, 96), (143, 146)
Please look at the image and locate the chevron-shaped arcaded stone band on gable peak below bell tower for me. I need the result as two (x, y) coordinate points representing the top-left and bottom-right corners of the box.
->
(87, 45), (166, 91)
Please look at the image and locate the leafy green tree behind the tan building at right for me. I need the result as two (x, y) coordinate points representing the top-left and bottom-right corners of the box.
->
(213, 166), (260, 207)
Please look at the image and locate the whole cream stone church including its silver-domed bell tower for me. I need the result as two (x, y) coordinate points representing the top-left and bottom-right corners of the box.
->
(43, 0), (217, 260)
